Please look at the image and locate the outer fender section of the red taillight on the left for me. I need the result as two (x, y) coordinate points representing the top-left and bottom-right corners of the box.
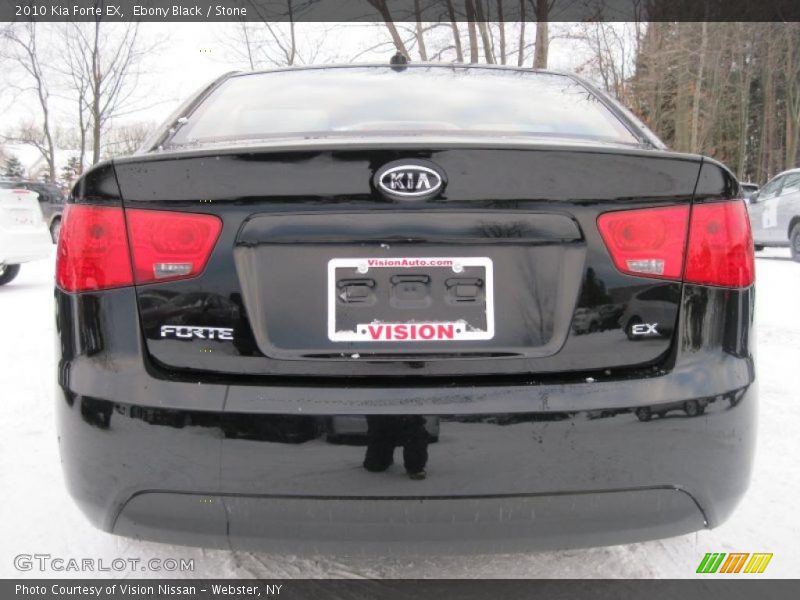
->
(56, 204), (133, 292)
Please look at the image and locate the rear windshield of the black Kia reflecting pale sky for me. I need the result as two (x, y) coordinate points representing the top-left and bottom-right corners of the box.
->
(170, 67), (638, 145)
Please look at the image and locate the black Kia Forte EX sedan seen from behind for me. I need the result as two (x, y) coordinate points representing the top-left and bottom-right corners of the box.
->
(56, 64), (757, 554)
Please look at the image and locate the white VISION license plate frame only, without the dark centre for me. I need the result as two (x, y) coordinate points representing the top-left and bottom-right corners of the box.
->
(326, 256), (495, 344)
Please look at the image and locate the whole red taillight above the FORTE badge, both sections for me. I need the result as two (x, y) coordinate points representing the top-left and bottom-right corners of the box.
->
(56, 204), (222, 292)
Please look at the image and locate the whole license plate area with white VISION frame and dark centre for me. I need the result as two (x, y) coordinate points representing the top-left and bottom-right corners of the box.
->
(327, 256), (494, 344)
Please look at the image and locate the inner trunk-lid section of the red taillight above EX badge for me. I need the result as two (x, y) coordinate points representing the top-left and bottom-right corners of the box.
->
(597, 206), (689, 279)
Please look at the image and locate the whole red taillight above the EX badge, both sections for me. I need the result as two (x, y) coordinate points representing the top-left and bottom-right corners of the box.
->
(597, 200), (755, 287)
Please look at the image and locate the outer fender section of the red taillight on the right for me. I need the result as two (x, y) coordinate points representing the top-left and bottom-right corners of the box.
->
(684, 200), (755, 287)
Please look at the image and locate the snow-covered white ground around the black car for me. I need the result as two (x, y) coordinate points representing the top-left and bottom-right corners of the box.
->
(0, 250), (800, 578)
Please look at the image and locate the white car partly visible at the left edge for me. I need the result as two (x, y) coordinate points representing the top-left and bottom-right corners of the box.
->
(0, 189), (53, 285)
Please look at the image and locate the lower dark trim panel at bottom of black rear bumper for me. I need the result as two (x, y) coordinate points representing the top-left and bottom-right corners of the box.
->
(113, 488), (705, 555)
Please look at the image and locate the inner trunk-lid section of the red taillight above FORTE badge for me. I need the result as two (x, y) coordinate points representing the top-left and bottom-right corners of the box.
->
(126, 209), (222, 283)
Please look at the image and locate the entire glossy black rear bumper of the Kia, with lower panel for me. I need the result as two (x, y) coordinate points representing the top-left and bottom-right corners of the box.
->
(57, 290), (757, 554)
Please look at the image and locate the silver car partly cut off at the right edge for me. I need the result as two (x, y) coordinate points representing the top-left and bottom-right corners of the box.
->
(747, 169), (800, 262)
